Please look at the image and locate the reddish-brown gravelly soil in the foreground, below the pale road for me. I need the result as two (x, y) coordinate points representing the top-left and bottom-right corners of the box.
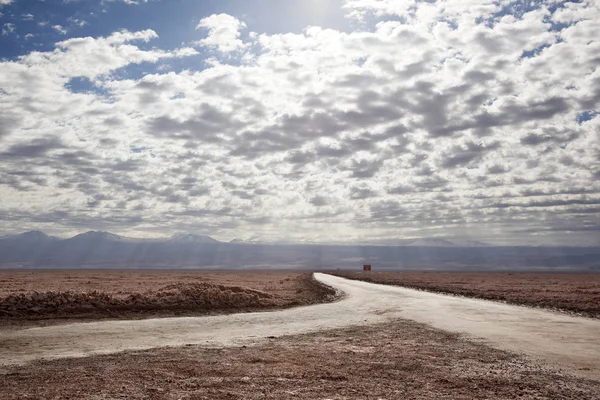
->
(0, 320), (600, 400)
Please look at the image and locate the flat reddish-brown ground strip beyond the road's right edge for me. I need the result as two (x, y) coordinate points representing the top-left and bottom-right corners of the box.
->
(331, 271), (600, 318)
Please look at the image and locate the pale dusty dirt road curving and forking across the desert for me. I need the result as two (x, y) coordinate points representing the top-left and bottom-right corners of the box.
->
(0, 273), (600, 379)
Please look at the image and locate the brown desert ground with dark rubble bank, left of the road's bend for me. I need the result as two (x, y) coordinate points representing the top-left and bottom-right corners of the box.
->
(0, 271), (335, 324)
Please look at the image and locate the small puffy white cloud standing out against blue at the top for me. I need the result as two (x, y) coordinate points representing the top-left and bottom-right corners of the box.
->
(196, 14), (246, 53)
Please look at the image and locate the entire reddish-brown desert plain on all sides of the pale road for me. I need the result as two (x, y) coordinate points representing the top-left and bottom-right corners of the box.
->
(0, 270), (600, 399)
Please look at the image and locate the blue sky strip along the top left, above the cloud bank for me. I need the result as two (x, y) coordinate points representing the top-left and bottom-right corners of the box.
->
(0, 0), (352, 59)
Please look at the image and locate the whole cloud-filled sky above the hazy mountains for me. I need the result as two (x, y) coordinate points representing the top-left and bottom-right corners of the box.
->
(0, 0), (600, 245)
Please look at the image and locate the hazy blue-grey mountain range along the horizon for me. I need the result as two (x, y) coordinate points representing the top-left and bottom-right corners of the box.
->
(0, 231), (600, 271)
